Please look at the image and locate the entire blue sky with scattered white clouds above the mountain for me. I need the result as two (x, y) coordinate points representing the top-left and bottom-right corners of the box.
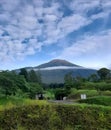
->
(0, 0), (111, 70)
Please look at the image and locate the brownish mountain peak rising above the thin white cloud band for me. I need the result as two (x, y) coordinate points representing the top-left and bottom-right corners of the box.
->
(36, 59), (79, 68)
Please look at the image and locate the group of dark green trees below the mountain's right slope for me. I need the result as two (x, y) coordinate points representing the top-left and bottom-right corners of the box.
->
(55, 68), (111, 99)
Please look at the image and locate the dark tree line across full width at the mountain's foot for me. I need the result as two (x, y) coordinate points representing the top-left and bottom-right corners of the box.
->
(0, 68), (111, 98)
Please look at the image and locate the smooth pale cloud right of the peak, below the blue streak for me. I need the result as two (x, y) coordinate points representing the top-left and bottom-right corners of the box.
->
(59, 29), (111, 65)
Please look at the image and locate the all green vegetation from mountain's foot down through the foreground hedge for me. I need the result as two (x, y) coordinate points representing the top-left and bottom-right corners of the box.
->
(0, 68), (111, 130)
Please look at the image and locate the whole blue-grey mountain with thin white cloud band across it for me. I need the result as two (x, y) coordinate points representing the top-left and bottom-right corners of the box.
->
(19, 59), (96, 84)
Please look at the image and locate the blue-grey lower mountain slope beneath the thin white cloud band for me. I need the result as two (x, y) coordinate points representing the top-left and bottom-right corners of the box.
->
(39, 69), (96, 84)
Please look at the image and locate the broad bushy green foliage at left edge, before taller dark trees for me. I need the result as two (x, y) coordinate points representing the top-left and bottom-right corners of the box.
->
(0, 71), (30, 96)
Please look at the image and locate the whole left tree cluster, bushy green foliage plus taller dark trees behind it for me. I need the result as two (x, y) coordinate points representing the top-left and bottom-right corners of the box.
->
(0, 68), (43, 98)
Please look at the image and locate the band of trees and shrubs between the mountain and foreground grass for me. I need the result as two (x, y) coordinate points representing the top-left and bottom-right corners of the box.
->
(0, 68), (111, 99)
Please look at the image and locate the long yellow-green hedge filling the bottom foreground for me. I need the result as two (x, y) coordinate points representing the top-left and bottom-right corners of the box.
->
(0, 104), (111, 130)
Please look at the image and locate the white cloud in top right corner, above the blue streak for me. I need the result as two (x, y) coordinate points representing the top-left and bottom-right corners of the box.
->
(68, 0), (111, 20)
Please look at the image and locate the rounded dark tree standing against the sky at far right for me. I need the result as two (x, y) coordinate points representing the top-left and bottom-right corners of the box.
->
(97, 68), (110, 80)
